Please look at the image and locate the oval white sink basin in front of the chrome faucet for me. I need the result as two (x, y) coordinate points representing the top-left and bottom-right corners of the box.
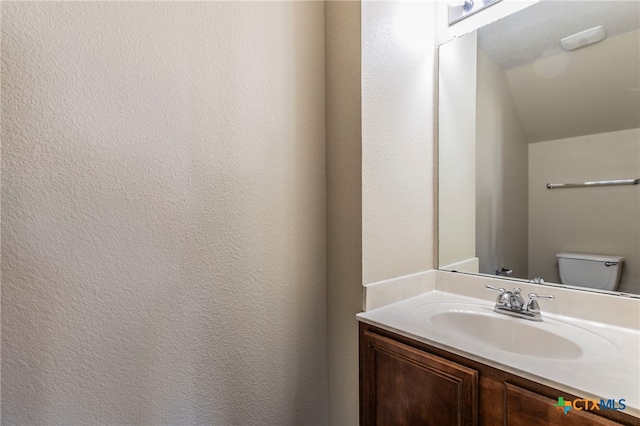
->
(413, 302), (618, 360)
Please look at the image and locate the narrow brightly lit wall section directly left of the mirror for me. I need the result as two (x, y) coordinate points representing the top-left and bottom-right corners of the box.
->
(362, 1), (435, 283)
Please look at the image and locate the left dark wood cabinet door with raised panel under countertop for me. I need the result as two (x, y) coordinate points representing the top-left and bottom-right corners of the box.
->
(360, 331), (478, 426)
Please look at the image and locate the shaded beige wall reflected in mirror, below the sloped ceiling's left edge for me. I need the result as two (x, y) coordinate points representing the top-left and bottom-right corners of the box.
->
(476, 49), (530, 278)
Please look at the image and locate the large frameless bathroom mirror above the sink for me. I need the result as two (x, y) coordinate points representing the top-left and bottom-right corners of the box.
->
(438, 1), (640, 295)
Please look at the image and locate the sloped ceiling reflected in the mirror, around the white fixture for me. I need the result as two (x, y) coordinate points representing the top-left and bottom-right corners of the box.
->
(478, 0), (640, 142)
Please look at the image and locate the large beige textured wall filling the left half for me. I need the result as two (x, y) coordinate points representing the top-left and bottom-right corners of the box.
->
(2, 2), (328, 425)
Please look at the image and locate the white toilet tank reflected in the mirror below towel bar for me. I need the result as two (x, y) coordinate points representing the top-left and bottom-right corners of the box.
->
(556, 253), (624, 290)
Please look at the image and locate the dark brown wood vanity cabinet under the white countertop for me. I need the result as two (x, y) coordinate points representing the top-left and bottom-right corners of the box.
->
(360, 323), (640, 426)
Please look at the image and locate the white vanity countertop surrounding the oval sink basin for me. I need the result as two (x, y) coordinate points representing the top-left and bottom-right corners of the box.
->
(357, 290), (640, 417)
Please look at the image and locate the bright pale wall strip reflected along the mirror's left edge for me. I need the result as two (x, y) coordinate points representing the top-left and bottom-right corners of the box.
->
(438, 33), (478, 268)
